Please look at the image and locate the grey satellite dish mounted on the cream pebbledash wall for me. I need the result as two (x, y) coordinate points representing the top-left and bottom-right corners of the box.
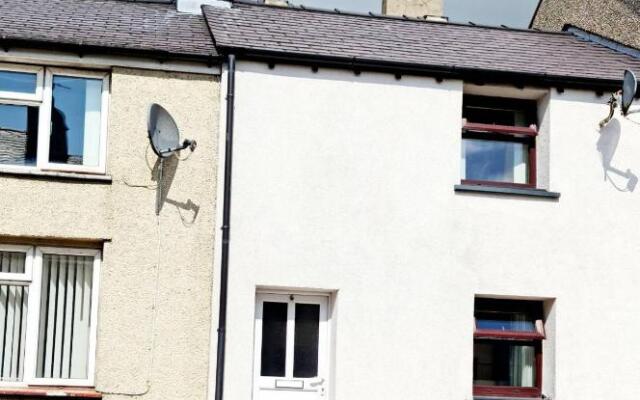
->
(147, 103), (196, 215)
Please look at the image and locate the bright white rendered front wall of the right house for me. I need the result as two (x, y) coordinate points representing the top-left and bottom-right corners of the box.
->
(225, 62), (640, 400)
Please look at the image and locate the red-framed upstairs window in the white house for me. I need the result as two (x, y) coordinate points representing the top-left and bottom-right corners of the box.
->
(461, 95), (538, 187)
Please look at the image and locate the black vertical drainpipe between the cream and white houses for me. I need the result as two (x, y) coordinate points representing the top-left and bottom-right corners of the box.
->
(215, 54), (236, 400)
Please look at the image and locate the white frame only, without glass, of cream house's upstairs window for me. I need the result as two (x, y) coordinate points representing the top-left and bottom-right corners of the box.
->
(0, 63), (110, 174)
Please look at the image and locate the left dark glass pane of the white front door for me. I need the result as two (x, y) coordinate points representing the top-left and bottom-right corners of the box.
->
(260, 301), (287, 376)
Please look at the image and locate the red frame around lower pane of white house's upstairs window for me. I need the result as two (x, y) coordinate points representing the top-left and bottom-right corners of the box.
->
(461, 120), (538, 189)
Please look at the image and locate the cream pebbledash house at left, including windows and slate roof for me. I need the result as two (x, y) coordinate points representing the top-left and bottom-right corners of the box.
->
(0, 0), (220, 399)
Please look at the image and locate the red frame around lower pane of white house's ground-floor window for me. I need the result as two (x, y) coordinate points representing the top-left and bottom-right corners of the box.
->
(473, 302), (545, 398)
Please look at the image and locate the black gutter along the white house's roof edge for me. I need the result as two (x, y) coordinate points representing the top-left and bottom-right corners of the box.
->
(218, 46), (622, 92)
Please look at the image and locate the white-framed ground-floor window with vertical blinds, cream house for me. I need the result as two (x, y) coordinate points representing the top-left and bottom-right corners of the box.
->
(0, 245), (100, 386)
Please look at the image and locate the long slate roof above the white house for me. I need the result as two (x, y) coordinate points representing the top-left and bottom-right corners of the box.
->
(204, 2), (640, 83)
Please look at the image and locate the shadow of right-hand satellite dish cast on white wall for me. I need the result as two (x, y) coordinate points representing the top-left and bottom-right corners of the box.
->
(596, 119), (638, 192)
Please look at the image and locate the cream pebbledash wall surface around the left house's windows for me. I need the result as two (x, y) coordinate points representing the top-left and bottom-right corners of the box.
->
(0, 68), (220, 400)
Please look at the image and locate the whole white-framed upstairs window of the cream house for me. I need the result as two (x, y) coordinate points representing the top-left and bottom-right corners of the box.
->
(0, 64), (108, 173)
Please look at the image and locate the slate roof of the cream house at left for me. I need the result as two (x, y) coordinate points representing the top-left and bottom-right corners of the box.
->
(0, 0), (217, 58)
